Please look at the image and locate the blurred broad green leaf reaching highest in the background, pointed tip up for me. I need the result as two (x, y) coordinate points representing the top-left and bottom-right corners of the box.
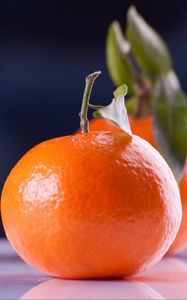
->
(126, 6), (172, 75)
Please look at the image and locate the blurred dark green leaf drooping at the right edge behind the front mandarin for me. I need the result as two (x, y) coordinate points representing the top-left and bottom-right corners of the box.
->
(154, 74), (187, 178)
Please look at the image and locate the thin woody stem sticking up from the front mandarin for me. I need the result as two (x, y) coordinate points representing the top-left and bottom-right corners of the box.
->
(79, 71), (101, 133)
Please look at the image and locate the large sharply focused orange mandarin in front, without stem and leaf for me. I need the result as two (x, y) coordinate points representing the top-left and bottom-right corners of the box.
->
(2, 132), (181, 279)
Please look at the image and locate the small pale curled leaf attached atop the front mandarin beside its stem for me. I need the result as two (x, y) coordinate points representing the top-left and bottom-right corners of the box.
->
(94, 84), (132, 136)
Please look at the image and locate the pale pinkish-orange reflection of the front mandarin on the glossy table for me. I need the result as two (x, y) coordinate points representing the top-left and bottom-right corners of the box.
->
(21, 279), (165, 300)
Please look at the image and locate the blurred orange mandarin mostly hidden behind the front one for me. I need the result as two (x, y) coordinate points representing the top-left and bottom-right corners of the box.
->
(90, 117), (187, 252)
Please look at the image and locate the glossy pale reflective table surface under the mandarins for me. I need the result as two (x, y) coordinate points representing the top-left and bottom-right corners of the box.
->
(0, 239), (187, 300)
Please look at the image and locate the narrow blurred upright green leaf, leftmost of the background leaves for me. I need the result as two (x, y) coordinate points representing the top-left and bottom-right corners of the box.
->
(106, 21), (133, 93)
